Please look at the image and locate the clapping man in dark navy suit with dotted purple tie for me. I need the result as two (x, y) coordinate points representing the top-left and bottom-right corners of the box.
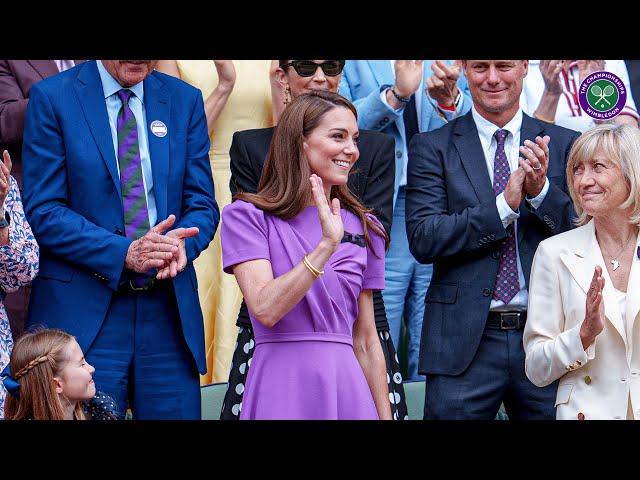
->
(406, 60), (579, 419)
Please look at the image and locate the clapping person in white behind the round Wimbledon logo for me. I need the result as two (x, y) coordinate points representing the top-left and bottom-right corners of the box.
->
(520, 60), (640, 132)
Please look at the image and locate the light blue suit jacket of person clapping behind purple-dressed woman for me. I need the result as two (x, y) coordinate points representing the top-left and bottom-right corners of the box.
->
(338, 60), (471, 205)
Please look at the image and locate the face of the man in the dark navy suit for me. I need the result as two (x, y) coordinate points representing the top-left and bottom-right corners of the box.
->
(463, 60), (529, 124)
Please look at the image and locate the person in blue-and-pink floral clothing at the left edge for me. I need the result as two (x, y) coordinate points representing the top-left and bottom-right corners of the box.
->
(0, 150), (39, 418)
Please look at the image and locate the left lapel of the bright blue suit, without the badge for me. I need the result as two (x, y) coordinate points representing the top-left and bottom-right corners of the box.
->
(74, 60), (122, 197)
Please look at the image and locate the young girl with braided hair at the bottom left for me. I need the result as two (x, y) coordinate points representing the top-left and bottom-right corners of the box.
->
(2, 329), (118, 420)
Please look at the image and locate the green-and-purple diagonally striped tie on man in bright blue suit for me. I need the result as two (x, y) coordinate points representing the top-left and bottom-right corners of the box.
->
(116, 89), (149, 240)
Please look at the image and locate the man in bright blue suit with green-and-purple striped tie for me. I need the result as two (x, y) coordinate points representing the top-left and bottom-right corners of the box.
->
(23, 60), (219, 419)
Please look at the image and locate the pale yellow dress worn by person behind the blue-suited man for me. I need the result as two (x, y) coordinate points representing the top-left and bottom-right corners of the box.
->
(177, 60), (273, 385)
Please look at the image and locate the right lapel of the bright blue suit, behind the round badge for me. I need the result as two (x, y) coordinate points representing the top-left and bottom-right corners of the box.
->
(144, 74), (173, 221)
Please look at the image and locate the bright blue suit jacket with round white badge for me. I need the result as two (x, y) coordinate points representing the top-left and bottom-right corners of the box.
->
(23, 61), (220, 373)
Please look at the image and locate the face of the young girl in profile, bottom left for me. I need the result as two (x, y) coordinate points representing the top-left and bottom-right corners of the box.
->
(54, 340), (96, 403)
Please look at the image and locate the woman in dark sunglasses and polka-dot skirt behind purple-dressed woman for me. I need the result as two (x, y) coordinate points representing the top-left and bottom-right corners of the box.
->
(221, 60), (407, 420)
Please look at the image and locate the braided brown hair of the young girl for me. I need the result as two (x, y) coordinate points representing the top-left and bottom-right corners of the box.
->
(4, 329), (85, 420)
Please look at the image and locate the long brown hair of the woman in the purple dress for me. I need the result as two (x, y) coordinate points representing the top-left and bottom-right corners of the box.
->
(234, 90), (389, 255)
